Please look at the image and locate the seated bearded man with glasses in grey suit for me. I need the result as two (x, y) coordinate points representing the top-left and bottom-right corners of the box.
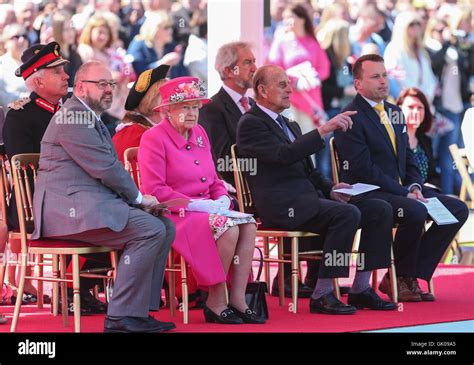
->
(32, 62), (175, 332)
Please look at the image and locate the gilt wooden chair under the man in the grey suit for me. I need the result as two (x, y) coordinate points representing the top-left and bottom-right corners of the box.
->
(11, 153), (118, 332)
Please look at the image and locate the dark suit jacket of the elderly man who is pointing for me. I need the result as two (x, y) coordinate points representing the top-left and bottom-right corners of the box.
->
(237, 105), (333, 230)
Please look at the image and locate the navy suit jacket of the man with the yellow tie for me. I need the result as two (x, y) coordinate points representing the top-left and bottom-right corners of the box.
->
(334, 94), (423, 196)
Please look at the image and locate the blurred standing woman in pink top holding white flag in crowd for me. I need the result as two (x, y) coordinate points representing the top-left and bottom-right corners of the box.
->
(268, 5), (330, 133)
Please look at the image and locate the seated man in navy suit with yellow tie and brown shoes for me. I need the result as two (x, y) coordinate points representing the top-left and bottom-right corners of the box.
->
(335, 54), (468, 302)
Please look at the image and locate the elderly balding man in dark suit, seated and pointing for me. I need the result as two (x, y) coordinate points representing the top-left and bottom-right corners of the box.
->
(237, 65), (396, 314)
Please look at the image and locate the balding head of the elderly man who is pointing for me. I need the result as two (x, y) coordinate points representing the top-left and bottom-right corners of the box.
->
(253, 65), (293, 113)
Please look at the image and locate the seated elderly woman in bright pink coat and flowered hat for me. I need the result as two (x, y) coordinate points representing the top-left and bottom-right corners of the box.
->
(138, 77), (264, 324)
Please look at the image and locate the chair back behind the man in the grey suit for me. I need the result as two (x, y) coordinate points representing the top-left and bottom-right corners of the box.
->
(11, 153), (40, 253)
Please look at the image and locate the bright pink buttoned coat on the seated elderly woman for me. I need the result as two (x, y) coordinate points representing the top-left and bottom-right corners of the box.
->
(138, 119), (227, 286)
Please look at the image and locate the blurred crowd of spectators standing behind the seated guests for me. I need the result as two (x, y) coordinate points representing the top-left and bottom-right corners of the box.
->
(0, 0), (474, 194)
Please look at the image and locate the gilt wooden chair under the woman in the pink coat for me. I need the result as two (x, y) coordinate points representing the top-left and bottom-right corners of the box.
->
(123, 147), (189, 324)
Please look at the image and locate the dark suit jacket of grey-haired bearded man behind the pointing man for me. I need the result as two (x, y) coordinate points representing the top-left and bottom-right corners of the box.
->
(199, 87), (255, 186)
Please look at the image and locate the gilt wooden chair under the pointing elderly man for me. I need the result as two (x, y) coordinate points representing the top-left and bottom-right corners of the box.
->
(231, 144), (340, 313)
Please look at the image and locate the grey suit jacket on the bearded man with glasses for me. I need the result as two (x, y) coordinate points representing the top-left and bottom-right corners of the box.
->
(32, 96), (138, 239)
